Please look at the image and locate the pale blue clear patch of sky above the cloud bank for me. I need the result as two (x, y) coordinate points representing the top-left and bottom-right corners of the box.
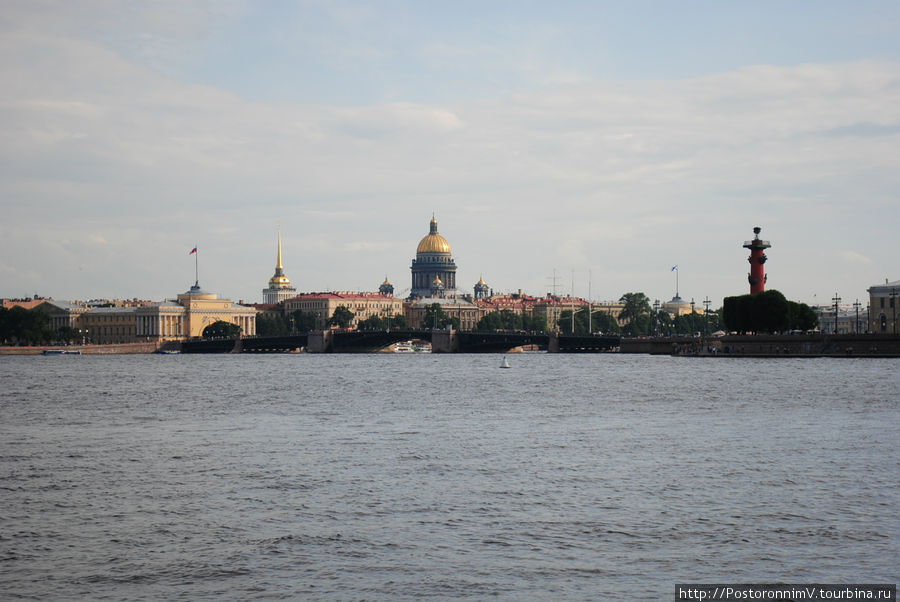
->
(95, 1), (900, 104)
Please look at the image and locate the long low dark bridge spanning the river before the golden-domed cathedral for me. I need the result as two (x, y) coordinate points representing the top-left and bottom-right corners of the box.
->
(181, 330), (621, 353)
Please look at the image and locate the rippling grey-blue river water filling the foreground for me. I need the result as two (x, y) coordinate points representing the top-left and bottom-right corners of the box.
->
(0, 353), (900, 600)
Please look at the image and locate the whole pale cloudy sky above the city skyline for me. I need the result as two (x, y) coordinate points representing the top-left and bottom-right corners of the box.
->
(0, 0), (900, 307)
